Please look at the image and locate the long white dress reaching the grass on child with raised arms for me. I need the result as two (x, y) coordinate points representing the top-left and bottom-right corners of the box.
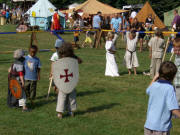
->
(105, 41), (119, 77)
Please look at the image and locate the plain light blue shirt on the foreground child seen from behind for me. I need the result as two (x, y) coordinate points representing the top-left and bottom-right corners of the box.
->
(144, 80), (179, 131)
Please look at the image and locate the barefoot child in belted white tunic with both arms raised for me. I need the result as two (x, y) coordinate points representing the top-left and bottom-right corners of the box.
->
(124, 31), (139, 75)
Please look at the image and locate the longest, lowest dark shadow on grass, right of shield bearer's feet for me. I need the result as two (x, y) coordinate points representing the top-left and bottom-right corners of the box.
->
(76, 103), (120, 115)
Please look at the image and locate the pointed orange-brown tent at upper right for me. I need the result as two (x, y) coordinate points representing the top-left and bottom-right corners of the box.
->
(136, 1), (166, 29)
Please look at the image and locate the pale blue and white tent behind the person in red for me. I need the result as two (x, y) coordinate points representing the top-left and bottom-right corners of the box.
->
(26, 0), (65, 30)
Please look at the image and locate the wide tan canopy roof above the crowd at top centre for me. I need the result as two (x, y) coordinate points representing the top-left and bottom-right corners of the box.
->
(62, 0), (127, 15)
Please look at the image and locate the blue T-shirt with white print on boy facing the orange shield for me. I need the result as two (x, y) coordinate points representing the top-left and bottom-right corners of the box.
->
(24, 55), (41, 81)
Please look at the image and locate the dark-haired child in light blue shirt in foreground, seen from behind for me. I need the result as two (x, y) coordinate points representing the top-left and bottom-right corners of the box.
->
(144, 62), (180, 135)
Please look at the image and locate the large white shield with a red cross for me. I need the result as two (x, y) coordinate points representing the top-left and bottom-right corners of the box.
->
(52, 57), (79, 94)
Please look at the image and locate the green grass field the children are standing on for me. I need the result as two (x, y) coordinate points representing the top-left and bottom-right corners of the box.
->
(0, 25), (180, 135)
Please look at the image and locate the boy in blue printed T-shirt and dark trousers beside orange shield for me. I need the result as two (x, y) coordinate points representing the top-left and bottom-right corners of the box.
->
(24, 45), (41, 101)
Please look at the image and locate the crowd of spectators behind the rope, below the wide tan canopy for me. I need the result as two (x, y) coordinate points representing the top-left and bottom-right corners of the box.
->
(69, 9), (156, 52)
